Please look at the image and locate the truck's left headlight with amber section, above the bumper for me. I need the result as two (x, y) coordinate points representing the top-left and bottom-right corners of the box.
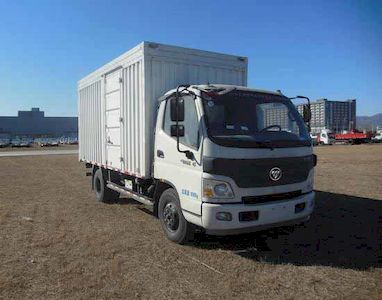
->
(203, 179), (234, 203)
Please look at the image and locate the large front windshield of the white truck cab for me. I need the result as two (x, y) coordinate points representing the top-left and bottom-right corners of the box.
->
(203, 90), (311, 148)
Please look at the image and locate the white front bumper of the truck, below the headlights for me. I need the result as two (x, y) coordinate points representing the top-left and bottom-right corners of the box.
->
(202, 192), (315, 235)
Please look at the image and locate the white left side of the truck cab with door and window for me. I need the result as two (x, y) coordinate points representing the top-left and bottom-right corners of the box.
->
(154, 96), (203, 221)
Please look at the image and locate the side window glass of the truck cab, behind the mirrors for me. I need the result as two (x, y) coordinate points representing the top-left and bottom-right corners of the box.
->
(163, 96), (200, 149)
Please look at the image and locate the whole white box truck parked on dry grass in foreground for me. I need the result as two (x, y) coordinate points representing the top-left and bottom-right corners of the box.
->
(78, 42), (316, 243)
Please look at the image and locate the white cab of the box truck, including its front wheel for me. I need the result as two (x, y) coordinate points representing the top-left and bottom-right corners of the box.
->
(153, 84), (316, 243)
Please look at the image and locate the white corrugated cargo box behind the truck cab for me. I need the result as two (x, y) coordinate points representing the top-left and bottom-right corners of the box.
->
(78, 42), (247, 178)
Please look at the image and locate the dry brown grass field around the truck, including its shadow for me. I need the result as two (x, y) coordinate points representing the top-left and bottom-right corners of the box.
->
(0, 145), (382, 299)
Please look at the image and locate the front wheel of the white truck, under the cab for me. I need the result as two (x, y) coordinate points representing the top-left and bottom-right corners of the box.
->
(158, 188), (194, 244)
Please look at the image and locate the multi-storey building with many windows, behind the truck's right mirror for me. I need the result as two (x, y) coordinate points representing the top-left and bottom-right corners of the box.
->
(297, 99), (356, 134)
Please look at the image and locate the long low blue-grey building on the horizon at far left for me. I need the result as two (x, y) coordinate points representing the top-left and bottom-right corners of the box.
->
(0, 108), (78, 137)
